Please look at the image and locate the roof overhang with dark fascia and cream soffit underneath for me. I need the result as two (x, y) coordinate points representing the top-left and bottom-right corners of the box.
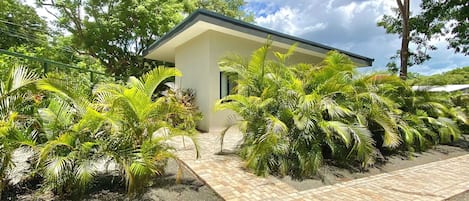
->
(143, 10), (374, 66)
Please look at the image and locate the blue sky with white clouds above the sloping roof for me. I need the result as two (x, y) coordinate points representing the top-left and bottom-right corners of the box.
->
(244, 0), (469, 75)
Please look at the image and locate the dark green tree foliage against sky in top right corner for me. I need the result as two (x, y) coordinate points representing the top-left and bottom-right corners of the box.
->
(378, 0), (469, 76)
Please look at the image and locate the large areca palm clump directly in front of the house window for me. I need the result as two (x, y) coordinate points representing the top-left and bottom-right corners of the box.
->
(217, 44), (374, 176)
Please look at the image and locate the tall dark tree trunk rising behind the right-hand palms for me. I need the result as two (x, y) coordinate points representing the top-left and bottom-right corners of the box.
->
(396, 0), (410, 80)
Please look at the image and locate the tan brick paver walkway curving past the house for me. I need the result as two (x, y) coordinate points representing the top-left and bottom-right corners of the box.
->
(170, 131), (469, 200)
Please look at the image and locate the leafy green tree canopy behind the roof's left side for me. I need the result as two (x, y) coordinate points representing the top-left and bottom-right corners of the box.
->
(37, 0), (249, 78)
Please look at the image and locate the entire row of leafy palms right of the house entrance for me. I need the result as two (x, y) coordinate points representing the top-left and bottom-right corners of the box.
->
(216, 43), (466, 178)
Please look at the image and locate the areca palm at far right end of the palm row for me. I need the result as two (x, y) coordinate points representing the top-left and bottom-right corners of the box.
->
(377, 75), (468, 151)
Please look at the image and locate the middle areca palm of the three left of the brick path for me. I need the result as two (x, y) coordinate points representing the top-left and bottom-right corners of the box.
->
(32, 98), (102, 196)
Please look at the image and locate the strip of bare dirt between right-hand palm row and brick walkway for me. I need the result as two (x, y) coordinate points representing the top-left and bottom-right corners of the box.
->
(280, 140), (469, 191)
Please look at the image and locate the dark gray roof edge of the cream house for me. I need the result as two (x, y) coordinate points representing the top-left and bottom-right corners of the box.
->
(143, 9), (374, 66)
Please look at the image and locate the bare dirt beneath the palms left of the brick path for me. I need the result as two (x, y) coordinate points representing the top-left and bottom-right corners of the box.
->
(1, 161), (223, 201)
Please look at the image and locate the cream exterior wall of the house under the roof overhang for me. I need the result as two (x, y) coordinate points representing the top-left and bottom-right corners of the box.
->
(175, 31), (321, 132)
